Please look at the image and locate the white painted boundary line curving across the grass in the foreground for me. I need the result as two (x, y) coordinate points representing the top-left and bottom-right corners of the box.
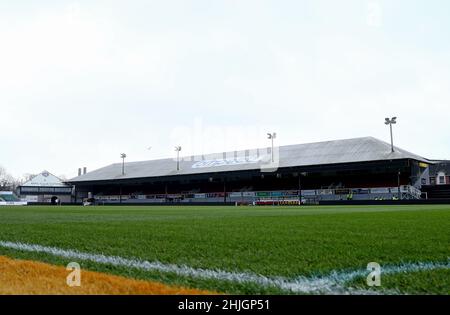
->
(0, 241), (450, 294)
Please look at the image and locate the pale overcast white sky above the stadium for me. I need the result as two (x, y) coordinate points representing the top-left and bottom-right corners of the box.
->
(0, 0), (450, 178)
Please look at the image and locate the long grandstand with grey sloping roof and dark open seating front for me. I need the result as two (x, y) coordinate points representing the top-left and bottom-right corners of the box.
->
(68, 137), (432, 204)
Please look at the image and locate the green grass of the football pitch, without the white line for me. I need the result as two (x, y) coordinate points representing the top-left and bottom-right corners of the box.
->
(0, 205), (450, 294)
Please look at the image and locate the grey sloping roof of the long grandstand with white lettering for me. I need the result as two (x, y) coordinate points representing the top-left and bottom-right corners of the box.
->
(69, 137), (430, 183)
